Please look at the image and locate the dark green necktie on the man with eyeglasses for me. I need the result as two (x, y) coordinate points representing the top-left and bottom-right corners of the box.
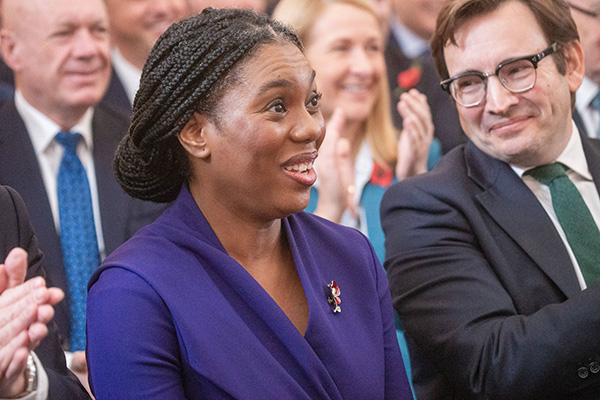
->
(526, 163), (600, 287)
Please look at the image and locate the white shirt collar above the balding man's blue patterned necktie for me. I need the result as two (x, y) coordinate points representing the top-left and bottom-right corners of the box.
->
(15, 90), (94, 154)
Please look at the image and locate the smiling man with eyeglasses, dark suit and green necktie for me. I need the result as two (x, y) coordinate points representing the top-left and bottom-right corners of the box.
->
(381, 0), (600, 400)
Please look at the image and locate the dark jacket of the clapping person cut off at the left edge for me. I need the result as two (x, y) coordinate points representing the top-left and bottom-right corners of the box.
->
(0, 186), (89, 400)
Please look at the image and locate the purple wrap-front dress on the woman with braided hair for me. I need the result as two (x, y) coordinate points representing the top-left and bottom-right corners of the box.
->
(87, 188), (412, 400)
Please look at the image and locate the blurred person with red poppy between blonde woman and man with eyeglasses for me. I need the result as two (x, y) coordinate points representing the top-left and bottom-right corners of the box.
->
(385, 0), (467, 153)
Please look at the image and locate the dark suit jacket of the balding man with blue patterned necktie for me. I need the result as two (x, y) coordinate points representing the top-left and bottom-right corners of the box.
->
(0, 100), (164, 346)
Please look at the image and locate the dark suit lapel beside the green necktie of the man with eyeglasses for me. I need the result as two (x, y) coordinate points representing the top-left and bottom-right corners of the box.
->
(465, 143), (581, 296)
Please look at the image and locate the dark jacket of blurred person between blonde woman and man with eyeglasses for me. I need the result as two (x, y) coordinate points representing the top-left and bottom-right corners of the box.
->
(385, 33), (467, 154)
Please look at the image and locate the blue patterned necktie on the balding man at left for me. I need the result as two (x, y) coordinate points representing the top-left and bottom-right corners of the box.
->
(56, 132), (100, 351)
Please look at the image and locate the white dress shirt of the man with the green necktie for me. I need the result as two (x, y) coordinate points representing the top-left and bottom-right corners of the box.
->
(512, 122), (600, 290)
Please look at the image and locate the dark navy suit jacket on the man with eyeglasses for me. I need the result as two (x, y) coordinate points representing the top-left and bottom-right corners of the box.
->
(381, 133), (600, 400)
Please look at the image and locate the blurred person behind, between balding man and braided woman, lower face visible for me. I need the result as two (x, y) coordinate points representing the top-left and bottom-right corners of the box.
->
(103, 0), (188, 112)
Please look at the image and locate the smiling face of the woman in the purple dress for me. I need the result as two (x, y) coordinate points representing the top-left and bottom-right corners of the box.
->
(190, 43), (325, 220)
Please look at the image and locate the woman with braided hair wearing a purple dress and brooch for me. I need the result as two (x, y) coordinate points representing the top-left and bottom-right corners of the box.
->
(87, 9), (412, 399)
